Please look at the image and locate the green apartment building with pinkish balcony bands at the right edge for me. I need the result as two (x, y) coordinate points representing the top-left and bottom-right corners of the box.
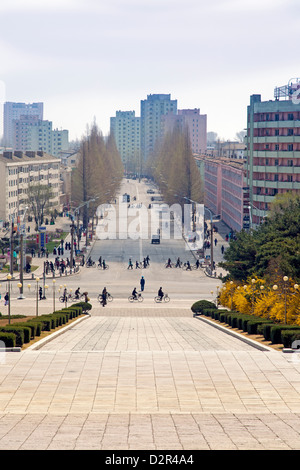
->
(244, 79), (300, 226)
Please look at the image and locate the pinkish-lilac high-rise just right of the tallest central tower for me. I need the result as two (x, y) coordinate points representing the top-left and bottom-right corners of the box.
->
(161, 108), (207, 154)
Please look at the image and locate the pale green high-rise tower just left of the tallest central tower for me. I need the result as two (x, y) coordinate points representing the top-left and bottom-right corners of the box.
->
(110, 111), (141, 170)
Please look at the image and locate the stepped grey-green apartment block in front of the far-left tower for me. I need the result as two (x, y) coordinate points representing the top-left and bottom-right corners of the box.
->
(12, 115), (69, 156)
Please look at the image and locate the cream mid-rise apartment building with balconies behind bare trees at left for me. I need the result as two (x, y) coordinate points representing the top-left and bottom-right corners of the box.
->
(0, 151), (61, 222)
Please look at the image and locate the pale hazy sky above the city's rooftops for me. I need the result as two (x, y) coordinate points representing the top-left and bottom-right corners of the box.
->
(0, 0), (300, 139)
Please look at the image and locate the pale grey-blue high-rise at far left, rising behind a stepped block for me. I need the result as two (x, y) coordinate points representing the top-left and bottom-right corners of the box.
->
(3, 101), (44, 147)
